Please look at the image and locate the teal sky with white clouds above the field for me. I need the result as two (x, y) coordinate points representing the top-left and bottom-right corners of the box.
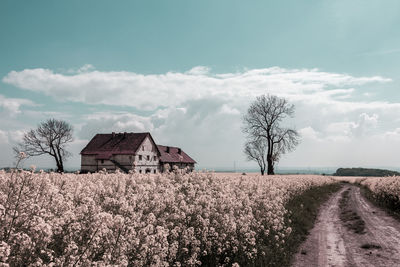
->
(0, 0), (400, 169)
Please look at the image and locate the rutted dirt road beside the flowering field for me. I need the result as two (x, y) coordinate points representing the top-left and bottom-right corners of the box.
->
(293, 185), (400, 267)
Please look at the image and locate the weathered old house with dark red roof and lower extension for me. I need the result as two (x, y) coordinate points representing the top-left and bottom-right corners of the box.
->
(81, 132), (196, 173)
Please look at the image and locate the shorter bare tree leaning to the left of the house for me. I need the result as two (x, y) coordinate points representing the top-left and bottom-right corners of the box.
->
(14, 119), (73, 172)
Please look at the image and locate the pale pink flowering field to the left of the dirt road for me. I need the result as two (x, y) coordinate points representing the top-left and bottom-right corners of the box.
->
(0, 170), (335, 266)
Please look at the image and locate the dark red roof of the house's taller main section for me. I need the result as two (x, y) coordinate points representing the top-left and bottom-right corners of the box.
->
(81, 133), (154, 159)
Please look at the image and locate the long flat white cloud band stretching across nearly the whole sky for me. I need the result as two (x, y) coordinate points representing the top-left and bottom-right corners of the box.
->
(3, 65), (391, 110)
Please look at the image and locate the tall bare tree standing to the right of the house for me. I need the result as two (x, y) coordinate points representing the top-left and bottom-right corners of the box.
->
(243, 95), (299, 174)
